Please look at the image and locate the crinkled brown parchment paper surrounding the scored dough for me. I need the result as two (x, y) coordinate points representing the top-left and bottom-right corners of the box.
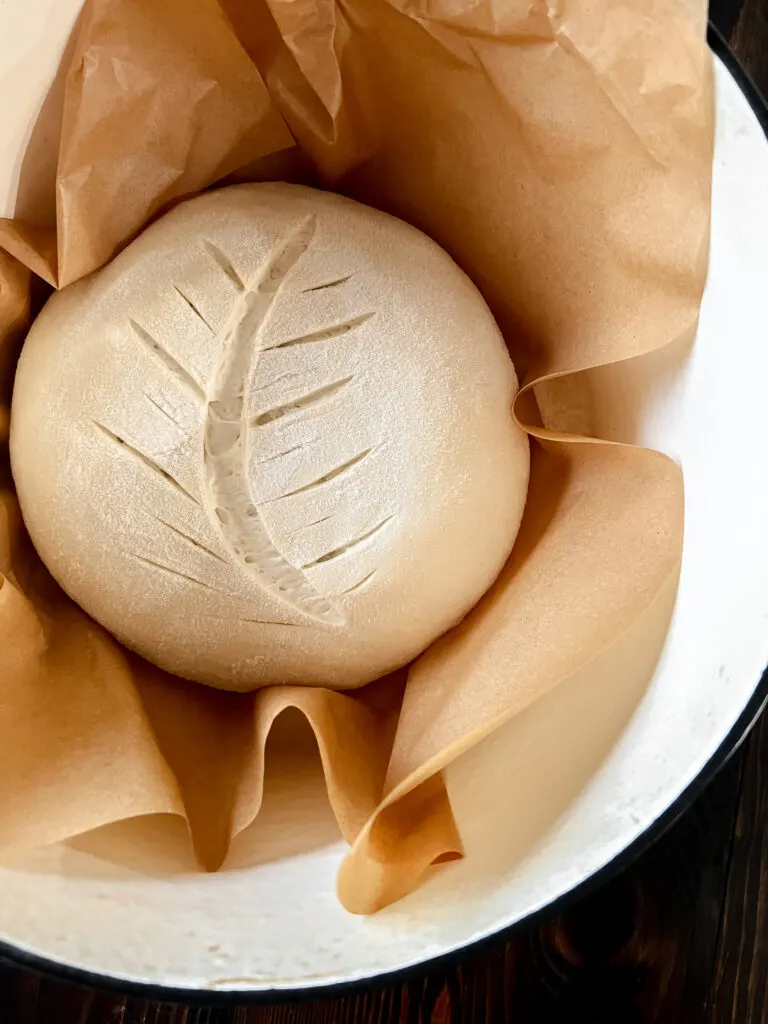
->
(0, 0), (713, 912)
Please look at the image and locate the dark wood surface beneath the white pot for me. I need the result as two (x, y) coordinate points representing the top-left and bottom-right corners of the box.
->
(0, 0), (768, 1024)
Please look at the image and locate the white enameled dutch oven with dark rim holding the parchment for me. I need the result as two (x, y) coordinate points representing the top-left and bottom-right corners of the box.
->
(0, 0), (768, 999)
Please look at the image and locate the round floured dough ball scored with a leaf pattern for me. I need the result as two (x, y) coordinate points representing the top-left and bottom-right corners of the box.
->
(11, 184), (528, 690)
